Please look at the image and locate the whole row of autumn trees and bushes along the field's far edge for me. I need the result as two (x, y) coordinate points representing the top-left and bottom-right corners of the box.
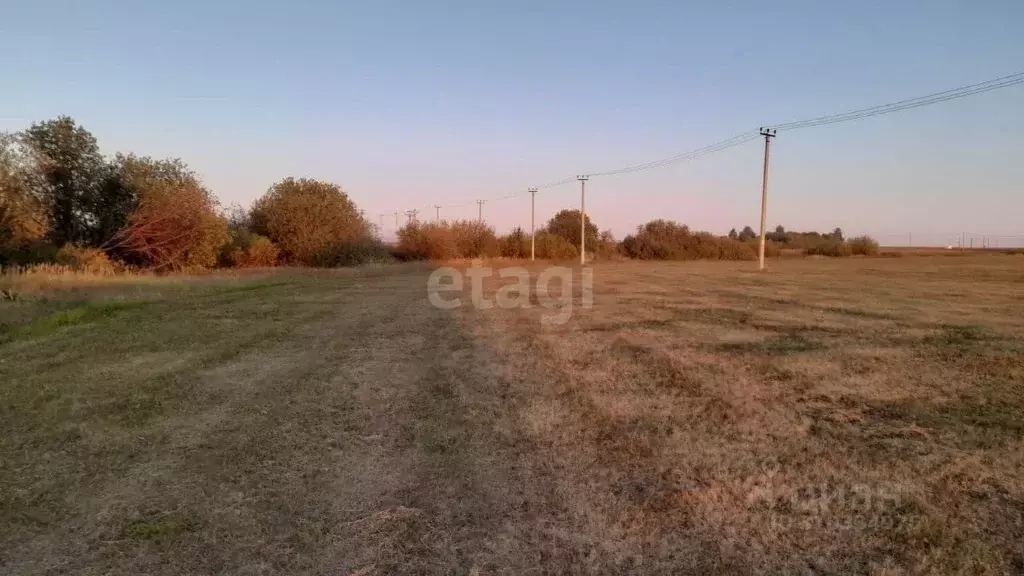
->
(0, 116), (878, 271)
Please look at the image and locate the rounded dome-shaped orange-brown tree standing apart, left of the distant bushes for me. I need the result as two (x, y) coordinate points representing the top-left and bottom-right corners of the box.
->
(252, 178), (373, 265)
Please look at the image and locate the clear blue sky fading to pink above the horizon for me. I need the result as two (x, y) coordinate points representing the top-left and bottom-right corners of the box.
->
(0, 0), (1024, 244)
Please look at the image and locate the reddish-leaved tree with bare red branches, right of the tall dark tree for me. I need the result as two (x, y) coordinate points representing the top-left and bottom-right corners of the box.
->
(106, 157), (227, 270)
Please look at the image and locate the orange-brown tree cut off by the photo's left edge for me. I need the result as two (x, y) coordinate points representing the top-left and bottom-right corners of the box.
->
(0, 133), (48, 252)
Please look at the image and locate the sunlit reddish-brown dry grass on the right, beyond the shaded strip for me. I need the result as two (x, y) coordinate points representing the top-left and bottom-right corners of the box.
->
(466, 256), (1024, 574)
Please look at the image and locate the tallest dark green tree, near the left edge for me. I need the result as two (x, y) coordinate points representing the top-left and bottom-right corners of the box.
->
(23, 116), (105, 246)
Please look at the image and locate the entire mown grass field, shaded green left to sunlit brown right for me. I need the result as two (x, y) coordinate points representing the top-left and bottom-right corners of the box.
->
(0, 255), (1024, 575)
